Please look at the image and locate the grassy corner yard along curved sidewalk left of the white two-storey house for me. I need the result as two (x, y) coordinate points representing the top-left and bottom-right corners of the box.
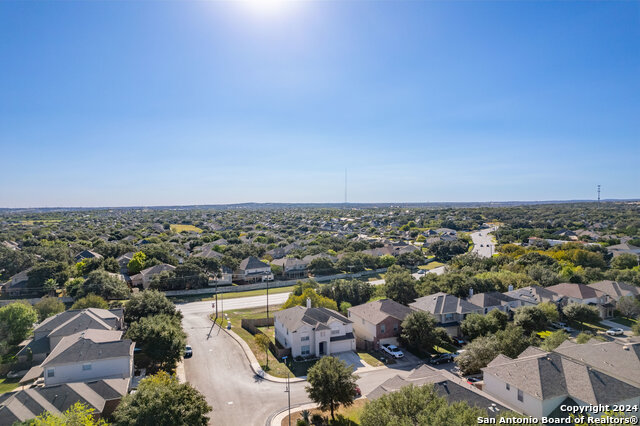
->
(218, 307), (315, 377)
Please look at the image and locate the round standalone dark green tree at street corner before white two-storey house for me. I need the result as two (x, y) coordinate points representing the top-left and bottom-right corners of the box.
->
(305, 356), (358, 420)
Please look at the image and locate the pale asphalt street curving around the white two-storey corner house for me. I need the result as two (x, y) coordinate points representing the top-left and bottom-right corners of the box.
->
(178, 295), (422, 426)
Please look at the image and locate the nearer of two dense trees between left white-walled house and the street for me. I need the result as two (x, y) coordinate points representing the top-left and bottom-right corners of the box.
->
(126, 315), (187, 371)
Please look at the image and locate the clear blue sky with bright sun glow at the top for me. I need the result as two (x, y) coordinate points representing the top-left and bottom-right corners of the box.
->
(0, 0), (640, 207)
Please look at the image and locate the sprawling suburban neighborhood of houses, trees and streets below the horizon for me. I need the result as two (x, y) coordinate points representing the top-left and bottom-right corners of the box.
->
(0, 202), (640, 426)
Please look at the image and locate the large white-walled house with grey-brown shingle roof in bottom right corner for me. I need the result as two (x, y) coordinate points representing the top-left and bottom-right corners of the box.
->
(482, 347), (640, 418)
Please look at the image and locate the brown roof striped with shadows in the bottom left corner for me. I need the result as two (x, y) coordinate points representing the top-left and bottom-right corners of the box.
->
(0, 379), (130, 426)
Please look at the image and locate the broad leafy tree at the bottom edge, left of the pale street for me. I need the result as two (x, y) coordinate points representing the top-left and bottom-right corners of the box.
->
(113, 371), (211, 426)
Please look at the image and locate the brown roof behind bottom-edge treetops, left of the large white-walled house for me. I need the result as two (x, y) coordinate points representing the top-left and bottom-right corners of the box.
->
(367, 365), (509, 417)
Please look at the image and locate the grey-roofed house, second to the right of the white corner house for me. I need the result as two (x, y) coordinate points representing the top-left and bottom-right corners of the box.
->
(409, 292), (484, 336)
